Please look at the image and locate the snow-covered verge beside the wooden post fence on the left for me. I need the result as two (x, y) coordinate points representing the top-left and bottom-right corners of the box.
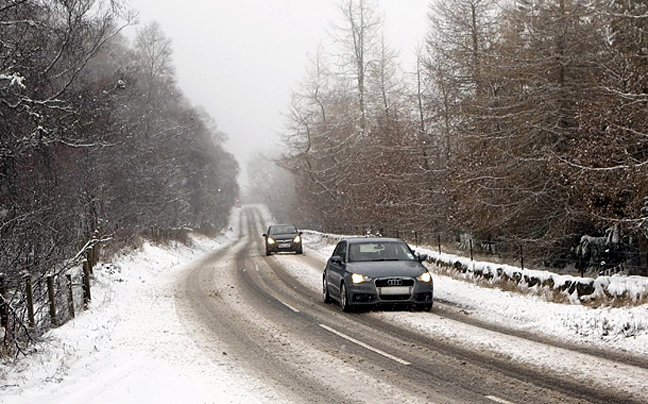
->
(0, 226), (258, 404)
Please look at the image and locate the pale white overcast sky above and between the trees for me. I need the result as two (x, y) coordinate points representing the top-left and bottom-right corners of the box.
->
(124, 0), (430, 182)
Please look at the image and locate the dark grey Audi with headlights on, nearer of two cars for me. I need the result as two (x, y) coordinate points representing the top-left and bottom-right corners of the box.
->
(322, 237), (434, 311)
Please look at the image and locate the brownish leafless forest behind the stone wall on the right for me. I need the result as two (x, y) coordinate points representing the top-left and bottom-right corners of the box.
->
(279, 0), (648, 275)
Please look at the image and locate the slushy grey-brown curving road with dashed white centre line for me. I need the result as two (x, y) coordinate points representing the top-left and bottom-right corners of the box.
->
(175, 208), (647, 404)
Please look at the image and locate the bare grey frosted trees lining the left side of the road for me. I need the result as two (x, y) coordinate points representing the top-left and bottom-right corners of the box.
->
(0, 0), (239, 318)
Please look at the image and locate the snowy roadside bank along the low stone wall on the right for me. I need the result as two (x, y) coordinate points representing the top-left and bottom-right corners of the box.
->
(304, 231), (648, 355)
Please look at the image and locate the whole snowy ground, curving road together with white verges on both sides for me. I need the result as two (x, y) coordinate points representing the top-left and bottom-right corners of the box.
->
(5, 206), (648, 404)
